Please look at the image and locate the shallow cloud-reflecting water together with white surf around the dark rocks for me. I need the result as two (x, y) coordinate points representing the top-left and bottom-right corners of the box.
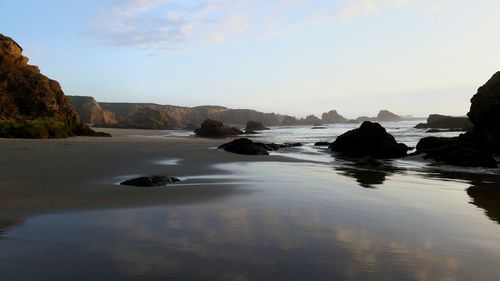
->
(0, 122), (500, 281)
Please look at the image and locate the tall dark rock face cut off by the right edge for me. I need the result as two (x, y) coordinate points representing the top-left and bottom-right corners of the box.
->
(467, 71), (500, 153)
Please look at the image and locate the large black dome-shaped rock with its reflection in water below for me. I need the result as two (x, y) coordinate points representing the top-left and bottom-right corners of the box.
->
(330, 121), (409, 159)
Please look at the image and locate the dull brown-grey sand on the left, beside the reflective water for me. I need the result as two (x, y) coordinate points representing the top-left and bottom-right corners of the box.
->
(0, 129), (297, 215)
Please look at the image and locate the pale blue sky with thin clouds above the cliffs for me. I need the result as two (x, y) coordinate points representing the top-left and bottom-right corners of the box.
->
(0, 0), (500, 118)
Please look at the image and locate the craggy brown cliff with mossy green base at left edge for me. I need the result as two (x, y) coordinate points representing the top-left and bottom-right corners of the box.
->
(0, 34), (105, 138)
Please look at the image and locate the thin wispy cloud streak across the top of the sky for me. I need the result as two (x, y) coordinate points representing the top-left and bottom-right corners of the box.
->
(92, 0), (434, 51)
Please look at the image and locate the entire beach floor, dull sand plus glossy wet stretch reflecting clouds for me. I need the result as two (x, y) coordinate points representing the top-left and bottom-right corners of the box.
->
(0, 129), (500, 280)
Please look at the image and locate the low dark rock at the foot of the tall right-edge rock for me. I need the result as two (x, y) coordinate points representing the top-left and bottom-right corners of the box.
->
(416, 134), (497, 168)
